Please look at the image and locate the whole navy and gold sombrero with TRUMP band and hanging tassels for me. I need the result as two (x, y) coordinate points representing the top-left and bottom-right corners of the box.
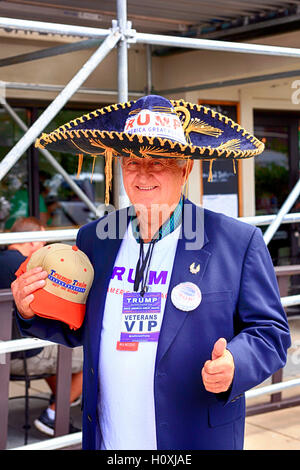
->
(35, 95), (264, 205)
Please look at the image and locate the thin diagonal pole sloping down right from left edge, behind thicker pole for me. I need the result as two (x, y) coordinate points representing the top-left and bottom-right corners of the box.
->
(0, 96), (103, 217)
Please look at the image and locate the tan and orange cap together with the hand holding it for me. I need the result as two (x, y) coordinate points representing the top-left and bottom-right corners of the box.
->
(12, 243), (94, 329)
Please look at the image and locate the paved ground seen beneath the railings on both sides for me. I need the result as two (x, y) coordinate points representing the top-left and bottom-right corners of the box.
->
(7, 319), (300, 450)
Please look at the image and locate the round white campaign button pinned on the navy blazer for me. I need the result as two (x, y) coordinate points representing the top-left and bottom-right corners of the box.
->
(171, 282), (202, 312)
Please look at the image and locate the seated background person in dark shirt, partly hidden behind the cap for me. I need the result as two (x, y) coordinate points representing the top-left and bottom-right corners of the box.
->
(0, 217), (83, 436)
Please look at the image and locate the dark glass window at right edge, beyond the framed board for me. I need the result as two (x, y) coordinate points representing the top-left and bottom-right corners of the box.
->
(254, 111), (300, 266)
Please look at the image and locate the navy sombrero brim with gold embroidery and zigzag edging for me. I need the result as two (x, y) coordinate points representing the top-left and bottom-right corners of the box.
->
(35, 100), (264, 160)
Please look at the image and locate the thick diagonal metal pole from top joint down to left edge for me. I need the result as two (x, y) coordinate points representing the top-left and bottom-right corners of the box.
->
(0, 31), (120, 181)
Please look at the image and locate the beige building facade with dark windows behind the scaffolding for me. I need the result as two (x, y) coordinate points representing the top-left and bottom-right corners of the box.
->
(0, 23), (300, 265)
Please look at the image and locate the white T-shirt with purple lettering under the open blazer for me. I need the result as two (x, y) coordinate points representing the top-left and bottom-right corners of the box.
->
(98, 224), (180, 450)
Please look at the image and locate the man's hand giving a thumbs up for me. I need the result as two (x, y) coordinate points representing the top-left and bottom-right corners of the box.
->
(202, 338), (234, 393)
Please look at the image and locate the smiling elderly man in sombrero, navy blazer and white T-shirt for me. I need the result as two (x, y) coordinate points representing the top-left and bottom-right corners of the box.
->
(13, 96), (290, 450)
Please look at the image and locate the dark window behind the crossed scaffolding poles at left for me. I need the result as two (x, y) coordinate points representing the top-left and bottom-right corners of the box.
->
(0, 107), (105, 230)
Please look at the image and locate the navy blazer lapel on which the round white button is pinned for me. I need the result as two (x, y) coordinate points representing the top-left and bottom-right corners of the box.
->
(156, 201), (211, 367)
